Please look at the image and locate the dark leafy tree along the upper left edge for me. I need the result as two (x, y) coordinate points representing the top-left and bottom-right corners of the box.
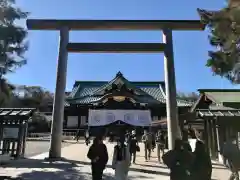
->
(0, 0), (28, 106)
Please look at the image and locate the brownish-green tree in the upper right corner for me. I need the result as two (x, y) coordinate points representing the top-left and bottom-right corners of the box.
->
(198, 0), (240, 84)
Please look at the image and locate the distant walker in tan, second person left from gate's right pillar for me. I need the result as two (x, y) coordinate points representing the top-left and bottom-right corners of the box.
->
(142, 130), (152, 161)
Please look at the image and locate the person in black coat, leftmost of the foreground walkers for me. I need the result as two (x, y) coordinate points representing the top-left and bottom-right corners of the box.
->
(87, 137), (108, 180)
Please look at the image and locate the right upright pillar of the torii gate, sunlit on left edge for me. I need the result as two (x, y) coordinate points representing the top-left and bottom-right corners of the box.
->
(163, 29), (181, 150)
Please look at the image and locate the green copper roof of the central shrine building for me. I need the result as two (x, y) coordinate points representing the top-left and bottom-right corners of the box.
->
(67, 73), (192, 106)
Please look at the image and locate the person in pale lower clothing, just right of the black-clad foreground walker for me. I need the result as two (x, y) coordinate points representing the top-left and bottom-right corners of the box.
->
(112, 137), (131, 180)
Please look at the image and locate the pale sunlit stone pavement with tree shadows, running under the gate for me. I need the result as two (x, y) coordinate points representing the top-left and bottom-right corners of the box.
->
(0, 143), (232, 180)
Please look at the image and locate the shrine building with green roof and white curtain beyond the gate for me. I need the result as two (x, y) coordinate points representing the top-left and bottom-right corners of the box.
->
(63, 72), (192, 135)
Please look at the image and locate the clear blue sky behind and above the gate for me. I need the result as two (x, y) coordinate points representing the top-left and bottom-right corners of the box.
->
(8, 0), (240, 92)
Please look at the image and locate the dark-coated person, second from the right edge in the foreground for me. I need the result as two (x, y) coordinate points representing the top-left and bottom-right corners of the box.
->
(192, 141), (212, 180)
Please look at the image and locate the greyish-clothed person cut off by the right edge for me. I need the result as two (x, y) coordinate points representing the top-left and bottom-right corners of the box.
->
(223, 136), (240, 180)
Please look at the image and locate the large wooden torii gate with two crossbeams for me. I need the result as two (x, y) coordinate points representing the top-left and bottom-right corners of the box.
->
(27, 19), (204, 158)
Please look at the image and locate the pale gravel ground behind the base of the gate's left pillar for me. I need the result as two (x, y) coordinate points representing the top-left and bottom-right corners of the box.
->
(25, 141), (71, 157)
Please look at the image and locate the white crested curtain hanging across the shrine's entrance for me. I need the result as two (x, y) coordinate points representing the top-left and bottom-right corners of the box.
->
(88, 109), (152, 126)
